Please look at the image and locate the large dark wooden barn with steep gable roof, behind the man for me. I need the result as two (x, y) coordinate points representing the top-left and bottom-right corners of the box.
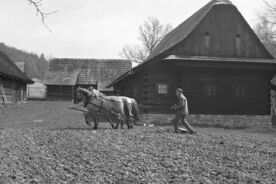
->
(108, 0), (276, 115)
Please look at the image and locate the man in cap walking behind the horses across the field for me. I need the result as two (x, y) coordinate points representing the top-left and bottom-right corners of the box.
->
(171, 88), (196, 134)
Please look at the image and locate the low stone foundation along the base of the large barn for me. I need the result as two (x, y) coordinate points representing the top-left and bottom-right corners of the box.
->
(143, 114), (271, 128)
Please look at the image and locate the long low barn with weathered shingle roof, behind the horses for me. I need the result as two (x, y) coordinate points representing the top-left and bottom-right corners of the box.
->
(44, 59), (131, 100)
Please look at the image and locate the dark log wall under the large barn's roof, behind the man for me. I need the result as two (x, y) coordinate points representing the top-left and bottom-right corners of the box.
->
(124, 63), (272, 115)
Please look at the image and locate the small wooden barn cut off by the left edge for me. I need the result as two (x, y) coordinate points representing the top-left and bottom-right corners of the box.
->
(0, 51), (33, 103)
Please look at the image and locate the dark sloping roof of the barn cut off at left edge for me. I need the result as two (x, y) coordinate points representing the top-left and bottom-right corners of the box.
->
(0, 51), (33, 83)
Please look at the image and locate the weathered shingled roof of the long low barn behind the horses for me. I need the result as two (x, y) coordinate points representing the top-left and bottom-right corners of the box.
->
(44, 59), (131, 90)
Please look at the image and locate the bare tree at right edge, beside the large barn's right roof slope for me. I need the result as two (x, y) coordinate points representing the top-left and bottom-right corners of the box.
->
(255, 0), (276, 56)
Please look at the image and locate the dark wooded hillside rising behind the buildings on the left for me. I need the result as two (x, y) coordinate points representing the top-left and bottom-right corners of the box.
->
(0, 43), (48, 79)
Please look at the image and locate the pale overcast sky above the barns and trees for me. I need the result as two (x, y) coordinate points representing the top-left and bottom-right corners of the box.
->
(0, 0), (268, 58)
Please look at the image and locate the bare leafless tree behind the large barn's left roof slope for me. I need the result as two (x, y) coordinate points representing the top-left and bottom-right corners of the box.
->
(120, 17), (172, 63)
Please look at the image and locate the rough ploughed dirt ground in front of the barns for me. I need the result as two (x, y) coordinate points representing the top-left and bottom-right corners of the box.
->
(0, 101), (276, 184)
